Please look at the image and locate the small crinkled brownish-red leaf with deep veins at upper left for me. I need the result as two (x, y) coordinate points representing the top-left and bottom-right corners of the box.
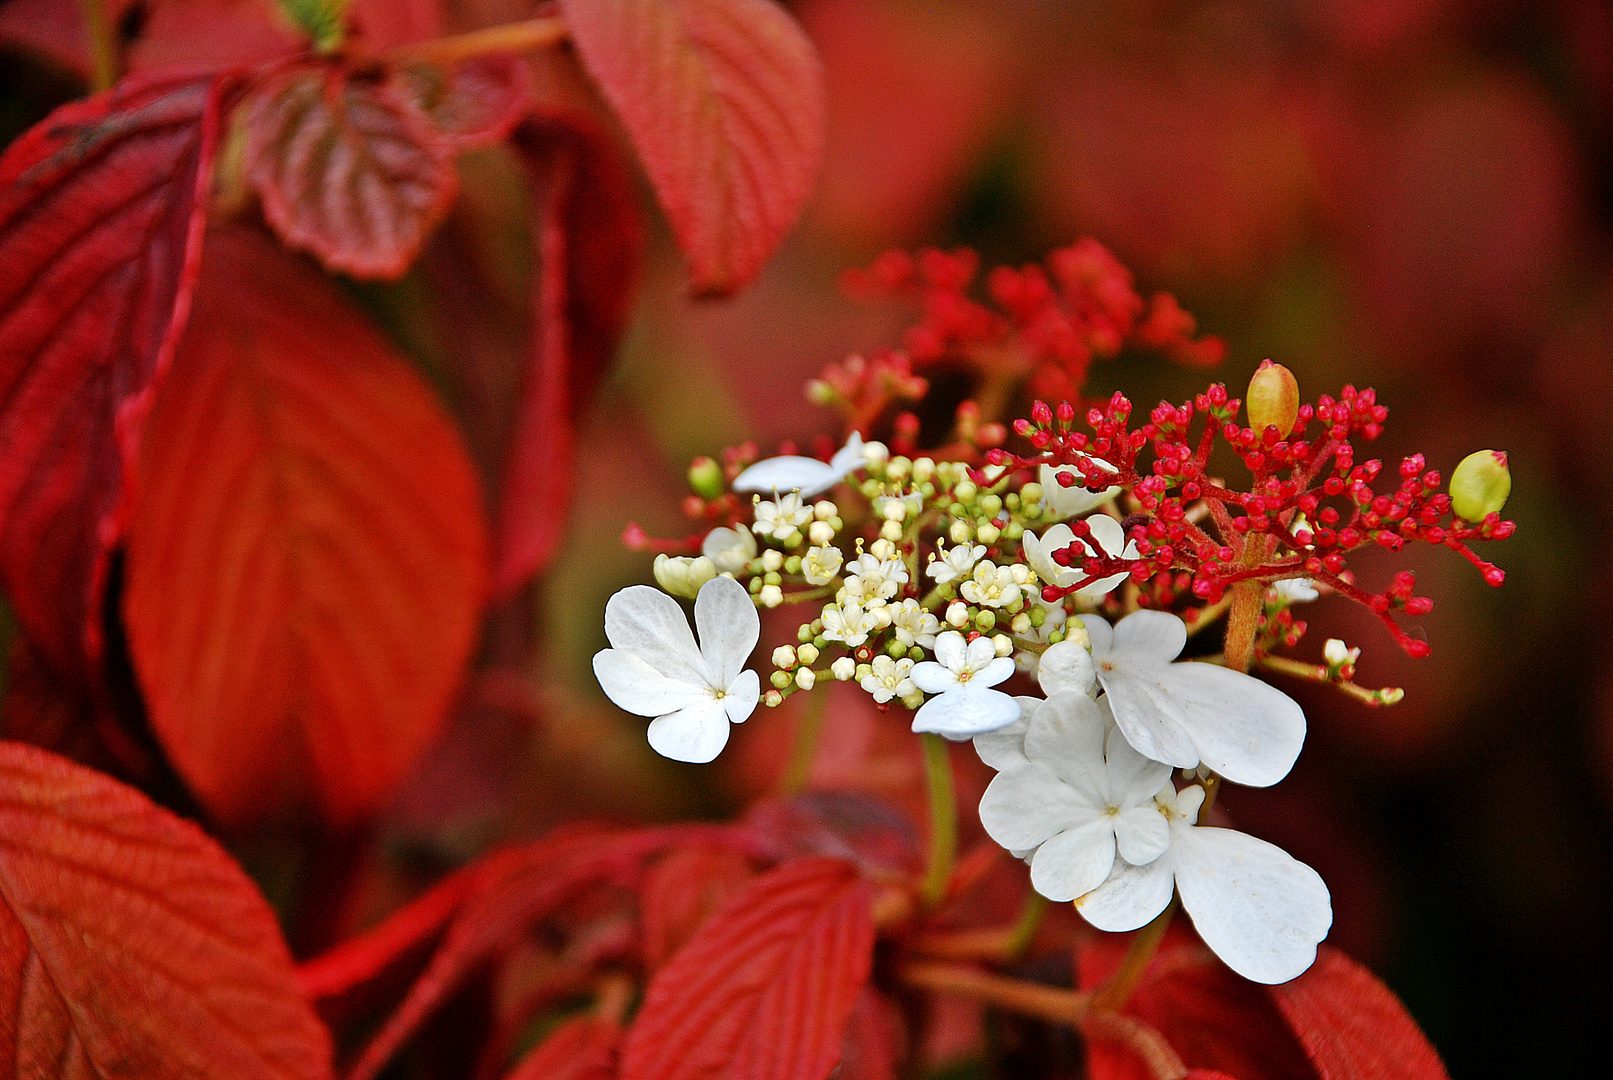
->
(244, 66), (458, 279)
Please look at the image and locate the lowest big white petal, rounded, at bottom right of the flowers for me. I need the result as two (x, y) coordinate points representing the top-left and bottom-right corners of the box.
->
(1171, 825), (1332, 983)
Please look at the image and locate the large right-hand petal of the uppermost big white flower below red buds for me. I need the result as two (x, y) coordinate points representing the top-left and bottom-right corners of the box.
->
(1154, 664), (1305, 788)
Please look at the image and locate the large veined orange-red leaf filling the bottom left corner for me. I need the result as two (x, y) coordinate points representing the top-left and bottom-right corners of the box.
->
(0, 743), (331, 1080)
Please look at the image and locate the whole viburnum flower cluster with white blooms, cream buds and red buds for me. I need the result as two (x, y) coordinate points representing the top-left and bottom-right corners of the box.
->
(602, 240), (1513, 982)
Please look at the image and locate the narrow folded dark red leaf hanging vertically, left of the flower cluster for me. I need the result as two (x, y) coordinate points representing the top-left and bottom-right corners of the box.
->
(494, 114), (640, 596)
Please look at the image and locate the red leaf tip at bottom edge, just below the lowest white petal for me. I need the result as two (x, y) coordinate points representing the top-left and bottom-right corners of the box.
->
(1268, 946), (1448, 1080)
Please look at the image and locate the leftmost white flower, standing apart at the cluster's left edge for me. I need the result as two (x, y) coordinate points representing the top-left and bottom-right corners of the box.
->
(594, 577), (761, 762)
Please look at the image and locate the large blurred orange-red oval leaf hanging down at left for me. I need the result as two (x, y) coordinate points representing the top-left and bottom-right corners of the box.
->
(124, 229), (487, 824)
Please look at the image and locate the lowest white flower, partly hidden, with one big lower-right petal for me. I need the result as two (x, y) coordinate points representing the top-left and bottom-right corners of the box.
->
(1076, 785), (1332, 983)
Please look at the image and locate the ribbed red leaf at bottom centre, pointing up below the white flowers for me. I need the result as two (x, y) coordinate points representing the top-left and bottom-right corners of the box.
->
(621, 859), (874, 1080)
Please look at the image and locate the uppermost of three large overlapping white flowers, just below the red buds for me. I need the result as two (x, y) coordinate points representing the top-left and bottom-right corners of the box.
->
(1077, 611), (1305, 787)
